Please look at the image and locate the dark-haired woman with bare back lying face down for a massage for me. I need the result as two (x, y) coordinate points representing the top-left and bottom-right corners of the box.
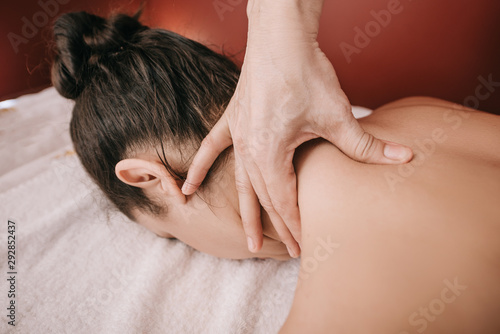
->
(52, 12), (500, 334)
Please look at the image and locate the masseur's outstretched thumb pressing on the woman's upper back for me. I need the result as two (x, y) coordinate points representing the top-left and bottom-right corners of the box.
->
(326, 117), (413, 164)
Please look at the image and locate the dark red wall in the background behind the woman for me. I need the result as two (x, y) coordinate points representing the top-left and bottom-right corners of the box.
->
(0, 0), (500, 114)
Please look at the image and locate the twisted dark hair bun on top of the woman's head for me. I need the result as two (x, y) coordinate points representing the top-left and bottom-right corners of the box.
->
(52, 12), (147, 99)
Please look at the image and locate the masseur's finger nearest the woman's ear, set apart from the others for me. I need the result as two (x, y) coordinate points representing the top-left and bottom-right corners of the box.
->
(182, 116), (233, 195)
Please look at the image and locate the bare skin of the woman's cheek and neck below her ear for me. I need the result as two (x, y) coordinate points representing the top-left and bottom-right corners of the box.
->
(134, 155), (290, 260)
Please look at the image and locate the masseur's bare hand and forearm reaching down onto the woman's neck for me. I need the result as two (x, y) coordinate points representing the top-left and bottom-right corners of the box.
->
(182, 0), (412, 256)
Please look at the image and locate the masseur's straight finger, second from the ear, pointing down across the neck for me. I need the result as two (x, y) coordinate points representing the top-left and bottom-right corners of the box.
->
(234, 152), (263, 253)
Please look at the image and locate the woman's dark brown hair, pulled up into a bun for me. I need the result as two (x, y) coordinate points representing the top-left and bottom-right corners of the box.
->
(52, 12), (239, 219)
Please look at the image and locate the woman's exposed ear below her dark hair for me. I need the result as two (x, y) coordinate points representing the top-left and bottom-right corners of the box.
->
(115, 159), (186, 204)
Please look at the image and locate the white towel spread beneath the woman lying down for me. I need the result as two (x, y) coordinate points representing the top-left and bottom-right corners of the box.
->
(0, 88), (369, 334)
